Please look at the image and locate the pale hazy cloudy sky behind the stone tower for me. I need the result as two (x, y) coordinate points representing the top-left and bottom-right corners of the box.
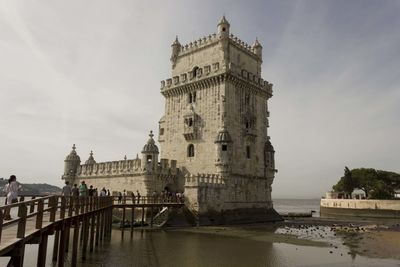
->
(0, 0), (400, 198)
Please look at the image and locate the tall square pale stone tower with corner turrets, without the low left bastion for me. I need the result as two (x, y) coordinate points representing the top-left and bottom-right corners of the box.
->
(158, 17), (276, 223)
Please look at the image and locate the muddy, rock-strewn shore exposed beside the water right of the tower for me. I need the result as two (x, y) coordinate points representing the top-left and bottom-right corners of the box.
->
(171, 217), (400, 260)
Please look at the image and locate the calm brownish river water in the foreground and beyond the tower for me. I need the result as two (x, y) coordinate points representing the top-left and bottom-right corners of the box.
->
(0, 200), (400, 267)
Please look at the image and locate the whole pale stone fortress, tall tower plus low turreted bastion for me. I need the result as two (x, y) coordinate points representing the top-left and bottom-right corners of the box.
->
(63, 17), (278, 224)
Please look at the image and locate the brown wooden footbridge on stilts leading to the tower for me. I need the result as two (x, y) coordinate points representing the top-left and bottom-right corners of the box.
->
(0, 196), (184, 267)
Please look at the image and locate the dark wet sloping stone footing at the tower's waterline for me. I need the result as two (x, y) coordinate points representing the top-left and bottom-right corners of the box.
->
(198, 208), (282, 225)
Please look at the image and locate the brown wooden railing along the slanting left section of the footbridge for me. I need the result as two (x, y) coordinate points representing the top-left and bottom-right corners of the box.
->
(0, 196), (113, 244)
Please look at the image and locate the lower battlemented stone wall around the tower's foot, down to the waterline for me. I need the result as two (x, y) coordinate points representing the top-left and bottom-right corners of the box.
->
(184, 174), (282, 225)
